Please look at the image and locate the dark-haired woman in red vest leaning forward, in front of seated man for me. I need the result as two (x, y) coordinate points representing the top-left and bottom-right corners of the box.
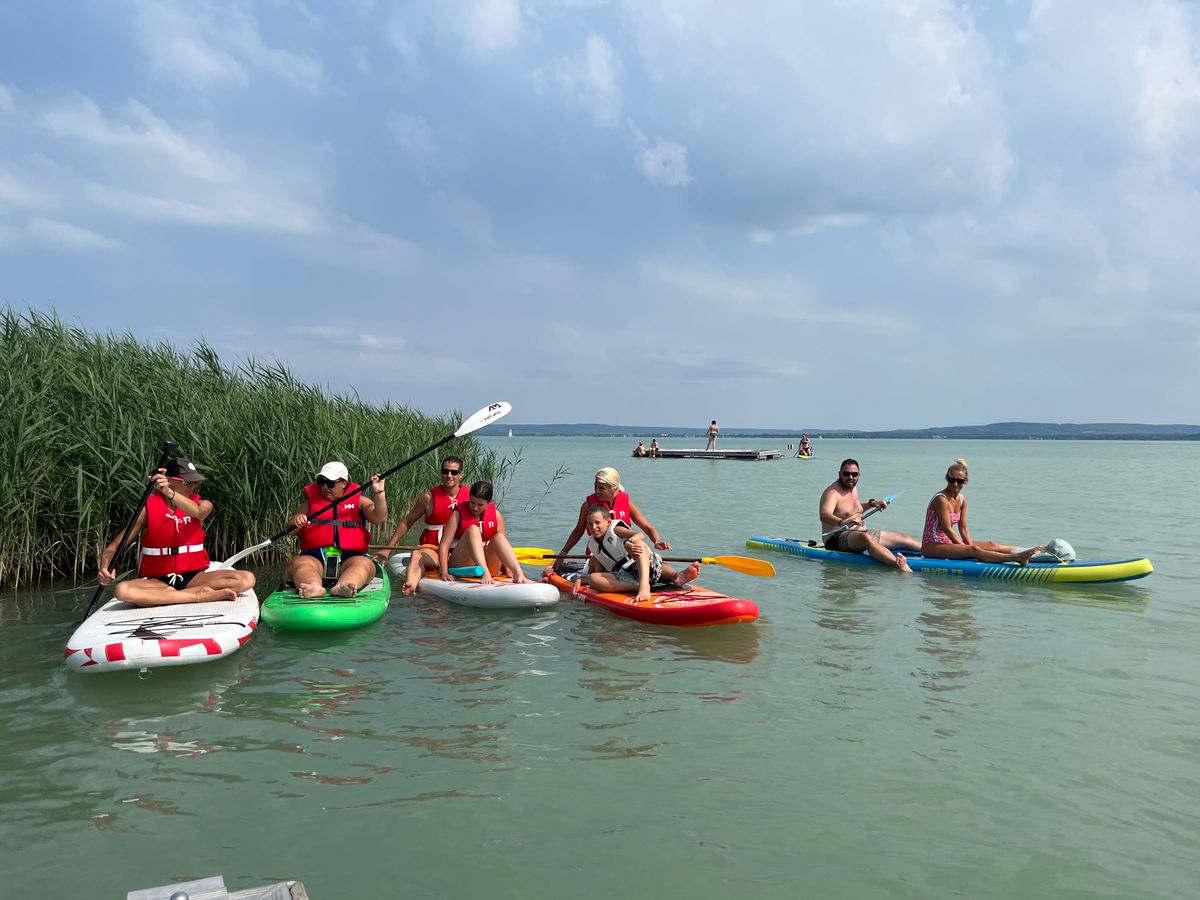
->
(402, 481), (528, 596)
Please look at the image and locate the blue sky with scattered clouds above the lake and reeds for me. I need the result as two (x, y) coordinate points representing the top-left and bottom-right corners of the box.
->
(0, 0), (1200, 430)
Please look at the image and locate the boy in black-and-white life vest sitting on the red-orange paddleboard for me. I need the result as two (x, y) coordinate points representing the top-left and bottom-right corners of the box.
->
(545, 503), (700, 601)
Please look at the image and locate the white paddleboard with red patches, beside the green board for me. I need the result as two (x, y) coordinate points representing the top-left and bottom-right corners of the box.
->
(62, 564), (258, 672)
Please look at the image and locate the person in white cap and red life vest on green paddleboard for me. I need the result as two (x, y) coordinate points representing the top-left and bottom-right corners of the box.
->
(287, 461), (388, 598)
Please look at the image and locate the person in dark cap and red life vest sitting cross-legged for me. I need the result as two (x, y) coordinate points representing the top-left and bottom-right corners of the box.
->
(98, 456), (254, 606)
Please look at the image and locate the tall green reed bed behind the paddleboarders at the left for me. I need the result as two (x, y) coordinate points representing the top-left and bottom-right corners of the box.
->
(0, 310), (509, 587)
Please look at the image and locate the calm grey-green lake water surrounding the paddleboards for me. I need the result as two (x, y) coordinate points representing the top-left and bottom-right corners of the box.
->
(0, 436), (1200, 900)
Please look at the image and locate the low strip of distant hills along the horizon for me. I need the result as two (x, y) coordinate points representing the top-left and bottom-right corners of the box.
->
(476, 422), (1200, 440)
